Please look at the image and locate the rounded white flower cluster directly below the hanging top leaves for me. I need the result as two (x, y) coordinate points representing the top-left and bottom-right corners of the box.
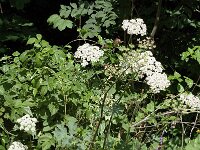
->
(74, 43), (104, 67)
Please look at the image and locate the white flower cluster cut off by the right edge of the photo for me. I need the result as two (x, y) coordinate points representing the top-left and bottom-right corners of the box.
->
(180, 93), (200, 110)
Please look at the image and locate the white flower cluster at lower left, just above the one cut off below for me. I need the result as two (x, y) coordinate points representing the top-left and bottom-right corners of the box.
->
(17, 114), (37, 133)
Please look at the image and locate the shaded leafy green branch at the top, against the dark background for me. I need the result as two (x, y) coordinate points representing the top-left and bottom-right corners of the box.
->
(47, 0), (117, 39)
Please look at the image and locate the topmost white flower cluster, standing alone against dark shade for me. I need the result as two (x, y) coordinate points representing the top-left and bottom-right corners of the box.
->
(122, 18), (147, 36)
